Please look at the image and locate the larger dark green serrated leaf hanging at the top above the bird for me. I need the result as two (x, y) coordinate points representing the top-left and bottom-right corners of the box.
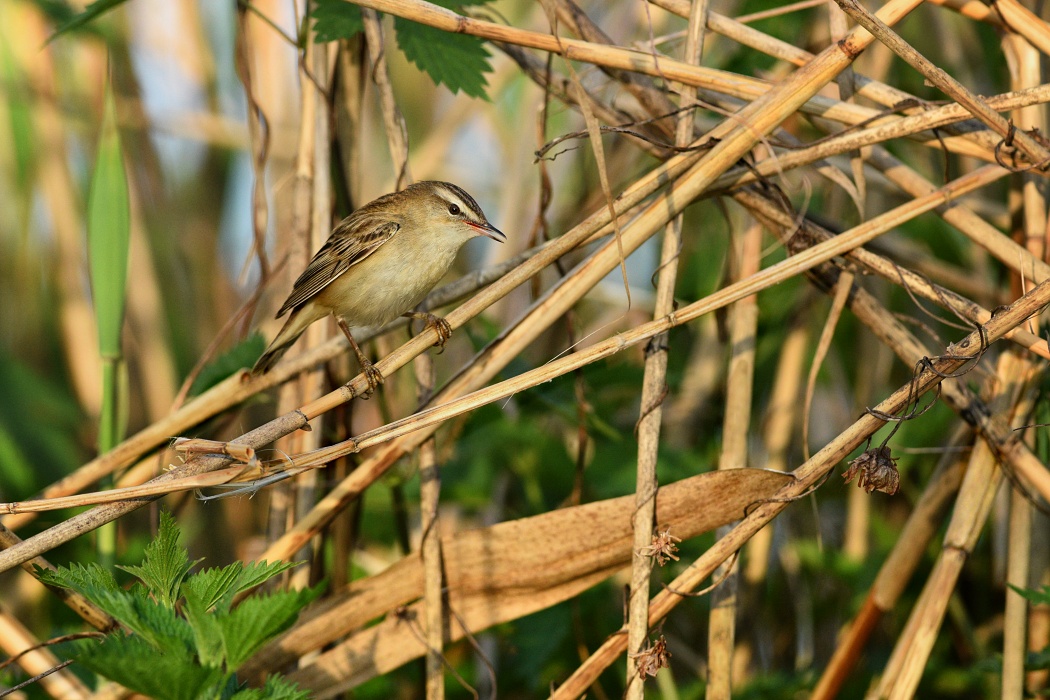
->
(394, 17), (492, 100)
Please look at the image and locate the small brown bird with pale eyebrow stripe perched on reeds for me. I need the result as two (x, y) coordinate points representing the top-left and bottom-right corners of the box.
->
(252, 181), (507, 389)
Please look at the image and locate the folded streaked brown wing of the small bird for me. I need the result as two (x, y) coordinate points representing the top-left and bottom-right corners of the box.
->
(277, 215), (401, 318)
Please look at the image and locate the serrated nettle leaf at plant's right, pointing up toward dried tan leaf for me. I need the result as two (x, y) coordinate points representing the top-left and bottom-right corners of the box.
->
(218, 586), (323, 671)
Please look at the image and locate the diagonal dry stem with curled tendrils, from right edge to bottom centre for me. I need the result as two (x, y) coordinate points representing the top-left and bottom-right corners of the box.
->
(551, 272), (1050, 700)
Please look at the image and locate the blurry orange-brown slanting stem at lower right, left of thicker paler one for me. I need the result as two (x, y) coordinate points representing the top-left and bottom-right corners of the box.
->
(811, 424), (972, 700)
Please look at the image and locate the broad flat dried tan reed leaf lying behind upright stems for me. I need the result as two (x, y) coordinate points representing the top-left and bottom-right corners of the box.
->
(249, 469), (792, 697)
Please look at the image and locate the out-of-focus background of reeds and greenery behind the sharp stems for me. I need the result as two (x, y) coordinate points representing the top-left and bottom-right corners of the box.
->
(0, 0), (1047, 698)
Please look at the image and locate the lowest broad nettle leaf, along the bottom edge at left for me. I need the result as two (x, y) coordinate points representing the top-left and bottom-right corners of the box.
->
(68, 633), (226, 700)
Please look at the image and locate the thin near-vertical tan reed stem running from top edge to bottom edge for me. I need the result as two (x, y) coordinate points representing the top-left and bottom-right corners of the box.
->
(624, 0), (709, 700)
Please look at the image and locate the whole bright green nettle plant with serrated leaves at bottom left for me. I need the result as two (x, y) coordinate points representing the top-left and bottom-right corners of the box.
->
(38, 513), (322, 700)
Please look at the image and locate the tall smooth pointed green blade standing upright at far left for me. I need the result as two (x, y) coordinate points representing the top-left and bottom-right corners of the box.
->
(85, 72), (131, 358)
